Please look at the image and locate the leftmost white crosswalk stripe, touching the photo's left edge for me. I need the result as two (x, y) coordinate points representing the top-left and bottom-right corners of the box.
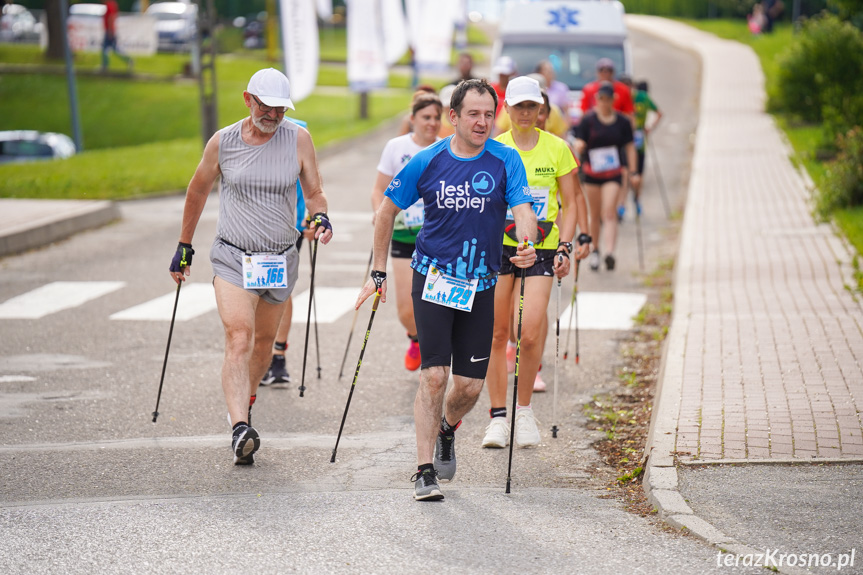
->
(0, 282), (126, 319)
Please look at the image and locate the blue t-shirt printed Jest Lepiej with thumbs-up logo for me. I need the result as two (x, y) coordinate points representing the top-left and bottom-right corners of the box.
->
(385, 136), (532, 291)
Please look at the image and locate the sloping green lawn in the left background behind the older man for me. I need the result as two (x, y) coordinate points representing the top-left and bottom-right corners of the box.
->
(0, 45), (411, 199)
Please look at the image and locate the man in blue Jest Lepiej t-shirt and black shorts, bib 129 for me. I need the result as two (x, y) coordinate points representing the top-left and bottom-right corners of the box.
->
(357, 80), (536, 500)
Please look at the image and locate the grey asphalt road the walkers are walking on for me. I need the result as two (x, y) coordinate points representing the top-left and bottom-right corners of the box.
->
(0, 30), (768, 573)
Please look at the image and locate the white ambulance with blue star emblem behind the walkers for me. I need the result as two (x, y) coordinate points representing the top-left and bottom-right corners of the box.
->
(492, 0), (632, 124)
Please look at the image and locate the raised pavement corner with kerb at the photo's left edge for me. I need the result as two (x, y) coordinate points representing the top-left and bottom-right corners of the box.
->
(0, 199), (120, 257)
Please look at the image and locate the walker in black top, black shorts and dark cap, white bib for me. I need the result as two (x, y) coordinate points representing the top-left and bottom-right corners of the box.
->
(575, 82), (641, 271)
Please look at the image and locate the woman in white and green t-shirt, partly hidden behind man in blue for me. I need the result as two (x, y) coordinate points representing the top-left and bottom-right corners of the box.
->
(372, 90), (442, 371)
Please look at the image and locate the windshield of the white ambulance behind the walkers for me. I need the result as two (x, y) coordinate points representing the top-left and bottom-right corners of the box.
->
(500, 44), (625, 90)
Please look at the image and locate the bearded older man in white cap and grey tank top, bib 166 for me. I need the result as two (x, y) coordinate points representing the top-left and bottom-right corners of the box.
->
(170, 68), (333, 465)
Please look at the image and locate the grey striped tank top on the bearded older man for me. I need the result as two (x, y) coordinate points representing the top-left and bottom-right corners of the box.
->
(216, 120), (300, 253)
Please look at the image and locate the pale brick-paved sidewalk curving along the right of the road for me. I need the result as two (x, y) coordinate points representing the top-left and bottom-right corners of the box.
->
(631, 17), (863, 460)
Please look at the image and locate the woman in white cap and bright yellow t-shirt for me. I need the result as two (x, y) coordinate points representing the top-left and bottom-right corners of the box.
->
(482, 76), (590, 447)
